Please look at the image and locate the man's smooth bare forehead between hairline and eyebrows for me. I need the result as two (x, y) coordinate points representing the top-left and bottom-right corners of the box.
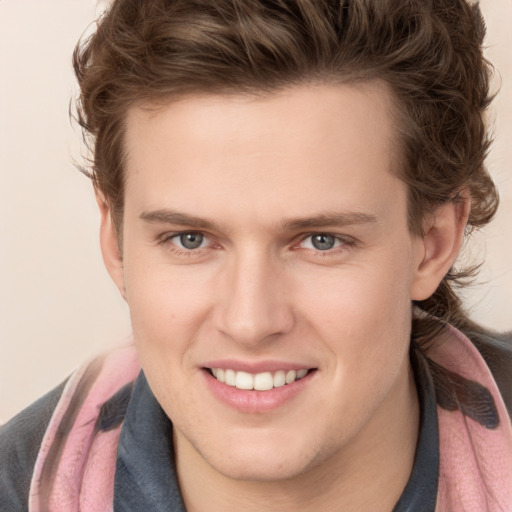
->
(125, 82), (400, 226)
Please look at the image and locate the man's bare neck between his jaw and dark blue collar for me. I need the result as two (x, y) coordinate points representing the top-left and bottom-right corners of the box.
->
(174, 360), (419, 512)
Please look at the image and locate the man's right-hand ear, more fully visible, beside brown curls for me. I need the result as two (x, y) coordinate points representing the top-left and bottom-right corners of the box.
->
(410, 192), (471, 301)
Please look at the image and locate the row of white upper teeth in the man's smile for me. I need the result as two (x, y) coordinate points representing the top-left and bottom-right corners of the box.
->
(211, 368), (308, 391)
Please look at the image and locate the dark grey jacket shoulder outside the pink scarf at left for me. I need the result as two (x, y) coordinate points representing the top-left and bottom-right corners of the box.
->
(0, 382), (66, 512)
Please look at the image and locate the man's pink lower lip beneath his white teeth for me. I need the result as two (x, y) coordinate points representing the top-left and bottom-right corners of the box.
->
(203, 370), (316, 413)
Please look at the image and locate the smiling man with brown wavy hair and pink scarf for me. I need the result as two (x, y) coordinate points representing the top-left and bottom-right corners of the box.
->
(2, 0), (512, 512)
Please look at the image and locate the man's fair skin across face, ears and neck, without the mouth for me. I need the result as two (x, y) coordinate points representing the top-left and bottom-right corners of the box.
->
(98, 82), (467, 512)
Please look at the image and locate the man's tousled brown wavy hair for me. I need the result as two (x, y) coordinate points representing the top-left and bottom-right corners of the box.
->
(73, 0), (504, 364)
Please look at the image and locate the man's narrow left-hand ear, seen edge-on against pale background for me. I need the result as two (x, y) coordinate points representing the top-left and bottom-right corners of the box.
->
(96, 192), (126, 300)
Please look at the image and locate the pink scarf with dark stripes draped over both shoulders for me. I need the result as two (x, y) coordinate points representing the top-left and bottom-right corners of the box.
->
(29, 328), (512, 512)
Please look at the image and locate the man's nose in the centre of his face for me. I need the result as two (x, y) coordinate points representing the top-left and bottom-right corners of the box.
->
(214, 251), (294, 347)
